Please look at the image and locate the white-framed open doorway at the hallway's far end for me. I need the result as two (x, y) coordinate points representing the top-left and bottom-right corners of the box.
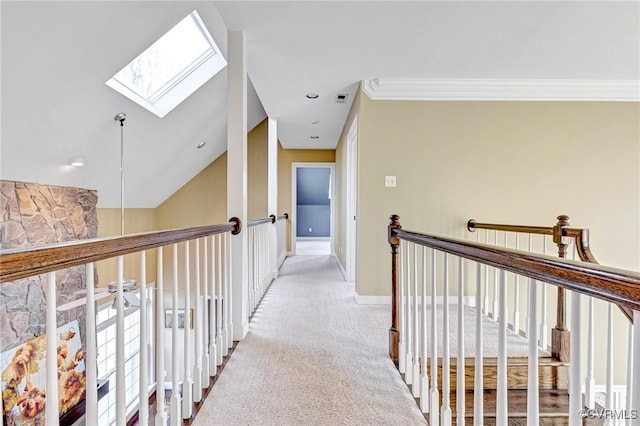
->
(291, 163), (335, 255)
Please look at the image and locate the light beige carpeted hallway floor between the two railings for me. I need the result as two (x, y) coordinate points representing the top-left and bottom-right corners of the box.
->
(193, 256), (426, 425)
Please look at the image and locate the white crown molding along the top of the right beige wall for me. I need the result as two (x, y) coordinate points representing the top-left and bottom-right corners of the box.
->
(362, 78), (640, 102)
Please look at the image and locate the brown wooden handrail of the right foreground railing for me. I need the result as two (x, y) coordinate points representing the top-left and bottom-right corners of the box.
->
(389, 227), (640, 310)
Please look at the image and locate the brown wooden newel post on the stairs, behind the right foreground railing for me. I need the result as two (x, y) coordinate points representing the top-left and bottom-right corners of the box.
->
(551, 215), (571, 362)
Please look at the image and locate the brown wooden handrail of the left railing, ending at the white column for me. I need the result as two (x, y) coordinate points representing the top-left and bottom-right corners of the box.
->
(0, 218), (241, 282)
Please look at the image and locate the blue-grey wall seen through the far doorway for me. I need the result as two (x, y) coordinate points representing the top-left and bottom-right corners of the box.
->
(296, 167), (331, 237)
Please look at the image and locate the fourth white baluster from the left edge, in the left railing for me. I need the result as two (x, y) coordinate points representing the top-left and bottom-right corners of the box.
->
(138, 251), (149, 425)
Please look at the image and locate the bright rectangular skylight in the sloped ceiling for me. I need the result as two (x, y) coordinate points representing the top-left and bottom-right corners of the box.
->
(106, 10), (227, 117)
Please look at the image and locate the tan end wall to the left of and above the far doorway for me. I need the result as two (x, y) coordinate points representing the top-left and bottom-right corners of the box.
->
(278, 145), (336, 251)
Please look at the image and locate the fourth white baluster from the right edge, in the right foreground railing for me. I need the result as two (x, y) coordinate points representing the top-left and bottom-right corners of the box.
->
(496, 269), (509, 426)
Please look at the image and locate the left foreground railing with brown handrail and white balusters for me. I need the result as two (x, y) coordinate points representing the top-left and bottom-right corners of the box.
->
(0, 218), (248, 425)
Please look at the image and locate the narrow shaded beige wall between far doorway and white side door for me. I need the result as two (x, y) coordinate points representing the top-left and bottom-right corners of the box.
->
(333, 91), (361, 268)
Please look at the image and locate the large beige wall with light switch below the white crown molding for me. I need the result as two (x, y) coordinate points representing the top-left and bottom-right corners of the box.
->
(356, 96), (640, 383)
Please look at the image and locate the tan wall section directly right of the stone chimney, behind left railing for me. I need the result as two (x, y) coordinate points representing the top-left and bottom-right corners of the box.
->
(97, 209), (158, 287)
